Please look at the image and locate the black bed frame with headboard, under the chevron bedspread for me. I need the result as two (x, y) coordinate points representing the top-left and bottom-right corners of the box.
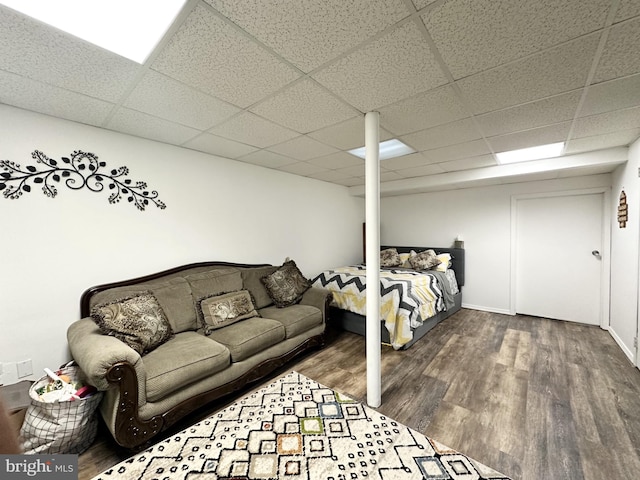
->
(329, 246), (465, 350)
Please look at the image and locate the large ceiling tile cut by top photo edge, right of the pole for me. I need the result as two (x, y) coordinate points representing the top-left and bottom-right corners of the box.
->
(421, 0), (611, 78)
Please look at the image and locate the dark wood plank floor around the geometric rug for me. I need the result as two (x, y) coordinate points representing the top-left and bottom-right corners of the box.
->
(79, 309), (640, 480)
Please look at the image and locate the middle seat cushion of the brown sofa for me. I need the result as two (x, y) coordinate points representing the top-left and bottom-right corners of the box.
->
(209, 317), (285, 362)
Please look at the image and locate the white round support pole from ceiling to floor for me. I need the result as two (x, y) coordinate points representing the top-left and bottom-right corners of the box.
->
(364, 112), (382, 408)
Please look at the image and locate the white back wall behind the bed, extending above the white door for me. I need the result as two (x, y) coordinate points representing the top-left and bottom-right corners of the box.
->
(380, 174), (611, 314)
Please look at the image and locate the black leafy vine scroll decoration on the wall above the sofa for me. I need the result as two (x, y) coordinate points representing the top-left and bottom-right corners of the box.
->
(0, 150), (166, 210)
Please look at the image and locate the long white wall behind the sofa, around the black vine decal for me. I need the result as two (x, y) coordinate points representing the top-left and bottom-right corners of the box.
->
(0, 105), (364, 383)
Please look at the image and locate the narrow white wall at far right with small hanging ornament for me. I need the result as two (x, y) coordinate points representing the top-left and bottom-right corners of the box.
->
(610, 140), (640, 362)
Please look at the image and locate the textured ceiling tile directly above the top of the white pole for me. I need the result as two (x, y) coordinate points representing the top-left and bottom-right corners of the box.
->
(313, 21), (447, 112)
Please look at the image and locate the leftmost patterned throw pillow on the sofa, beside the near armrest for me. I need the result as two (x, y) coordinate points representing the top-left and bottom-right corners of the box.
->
(91, 292), (173, 355)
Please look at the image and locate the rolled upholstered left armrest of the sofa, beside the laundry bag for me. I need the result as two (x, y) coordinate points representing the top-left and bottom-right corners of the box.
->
(67, 318), (146, 390)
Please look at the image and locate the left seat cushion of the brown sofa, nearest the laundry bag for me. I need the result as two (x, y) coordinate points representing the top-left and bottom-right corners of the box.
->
(142, 332), (231, 402)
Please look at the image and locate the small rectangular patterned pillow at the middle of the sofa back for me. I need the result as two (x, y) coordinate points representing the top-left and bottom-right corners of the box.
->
(198, 290), (260, 335)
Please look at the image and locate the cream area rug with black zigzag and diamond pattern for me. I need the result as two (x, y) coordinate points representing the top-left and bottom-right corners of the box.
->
(94, 372), (508, 480)
